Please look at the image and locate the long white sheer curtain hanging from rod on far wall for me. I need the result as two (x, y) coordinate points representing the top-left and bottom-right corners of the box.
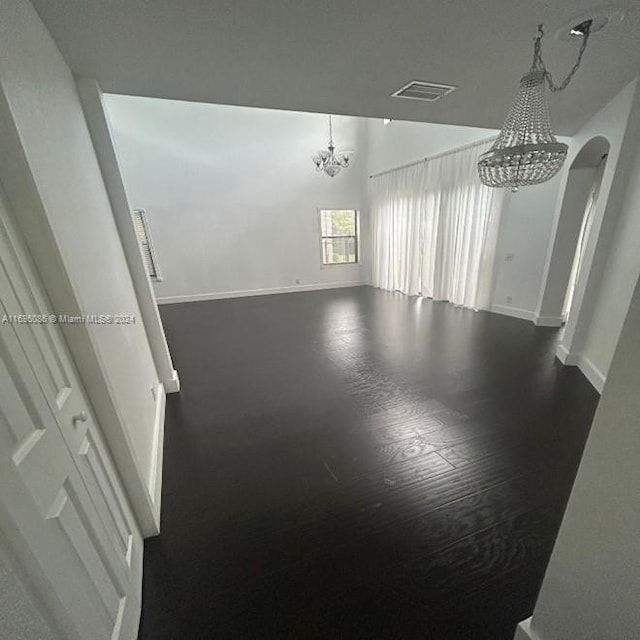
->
(371, 141), (503, 309)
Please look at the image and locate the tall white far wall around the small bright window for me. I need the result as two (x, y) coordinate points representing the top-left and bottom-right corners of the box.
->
(105, 95), (369, 302)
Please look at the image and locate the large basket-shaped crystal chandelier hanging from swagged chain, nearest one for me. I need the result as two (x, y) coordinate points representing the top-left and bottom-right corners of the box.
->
(478, 20), (592, 191)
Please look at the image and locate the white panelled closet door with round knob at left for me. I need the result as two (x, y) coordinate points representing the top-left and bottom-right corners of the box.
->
(0, 181), (142, 640)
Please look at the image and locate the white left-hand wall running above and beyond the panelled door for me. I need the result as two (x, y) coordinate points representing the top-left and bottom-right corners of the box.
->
(0, 0), (162, 533)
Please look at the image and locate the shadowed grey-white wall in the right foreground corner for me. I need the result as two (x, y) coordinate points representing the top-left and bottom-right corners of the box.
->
(517, 272), (640, 640)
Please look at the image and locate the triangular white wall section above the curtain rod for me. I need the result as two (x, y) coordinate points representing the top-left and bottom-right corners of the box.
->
(367, 118), (498, 175)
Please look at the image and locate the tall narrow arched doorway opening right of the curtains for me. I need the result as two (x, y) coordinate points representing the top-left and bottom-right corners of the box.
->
(538, 136), (609, 326)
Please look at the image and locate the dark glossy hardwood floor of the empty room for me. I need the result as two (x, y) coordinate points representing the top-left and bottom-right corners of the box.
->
(140, 287), (598, 640)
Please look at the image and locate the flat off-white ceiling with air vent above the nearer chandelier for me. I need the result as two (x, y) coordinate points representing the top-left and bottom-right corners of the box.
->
(33, 0), (640, 134)
